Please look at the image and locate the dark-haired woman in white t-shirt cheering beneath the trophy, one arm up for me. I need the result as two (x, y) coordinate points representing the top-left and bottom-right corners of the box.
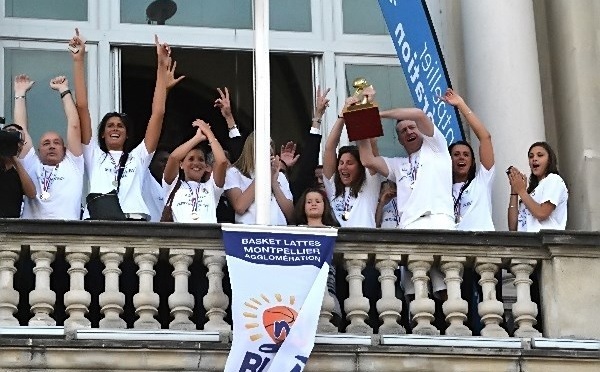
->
(323, 97), (381, 228)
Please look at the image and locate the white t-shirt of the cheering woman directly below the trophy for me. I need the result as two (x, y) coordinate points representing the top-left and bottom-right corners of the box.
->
(323, 169), (381, 228)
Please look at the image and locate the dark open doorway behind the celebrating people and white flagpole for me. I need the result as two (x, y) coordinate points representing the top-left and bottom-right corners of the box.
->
(121, 46), (313, 154)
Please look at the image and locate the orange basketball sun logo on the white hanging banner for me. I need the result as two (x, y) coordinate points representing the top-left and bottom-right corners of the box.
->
(243, 294), (298, 345)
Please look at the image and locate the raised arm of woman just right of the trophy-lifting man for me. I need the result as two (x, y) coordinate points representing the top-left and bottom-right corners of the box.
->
(441, 88), (494, 169)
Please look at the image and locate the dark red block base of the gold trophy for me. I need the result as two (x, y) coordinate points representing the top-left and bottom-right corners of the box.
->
(344, 104), (383, 141)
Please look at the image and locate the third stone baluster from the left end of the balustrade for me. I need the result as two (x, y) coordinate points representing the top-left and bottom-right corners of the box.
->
(64, 246), (92, 330)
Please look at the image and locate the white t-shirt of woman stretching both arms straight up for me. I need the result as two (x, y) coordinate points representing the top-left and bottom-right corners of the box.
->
(83, 142), (152, 219)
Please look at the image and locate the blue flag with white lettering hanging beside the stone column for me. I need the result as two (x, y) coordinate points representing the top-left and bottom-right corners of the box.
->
(379, 0), (464, 145)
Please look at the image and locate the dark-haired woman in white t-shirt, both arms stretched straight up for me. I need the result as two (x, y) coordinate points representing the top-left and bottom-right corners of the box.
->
(69, 29), (183, 221)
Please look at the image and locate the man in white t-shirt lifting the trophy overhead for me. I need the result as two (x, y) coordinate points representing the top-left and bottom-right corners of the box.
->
(358, 108), (455, 294)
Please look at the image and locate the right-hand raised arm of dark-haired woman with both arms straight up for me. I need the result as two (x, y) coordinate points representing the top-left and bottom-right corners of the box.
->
(144, 35), (171, 153)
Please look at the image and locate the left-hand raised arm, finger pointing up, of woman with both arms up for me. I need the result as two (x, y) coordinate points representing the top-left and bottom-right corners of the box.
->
(67, 28), (92, 145)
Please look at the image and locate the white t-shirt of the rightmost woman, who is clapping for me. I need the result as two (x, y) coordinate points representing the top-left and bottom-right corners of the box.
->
(517, 173), (569, 232)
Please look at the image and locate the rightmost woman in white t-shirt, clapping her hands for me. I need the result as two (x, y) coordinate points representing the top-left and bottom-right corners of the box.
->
(506, 142), (569, 232)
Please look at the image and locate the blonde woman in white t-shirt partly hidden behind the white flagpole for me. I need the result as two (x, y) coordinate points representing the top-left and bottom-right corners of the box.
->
(224, 132), (294, 225)
